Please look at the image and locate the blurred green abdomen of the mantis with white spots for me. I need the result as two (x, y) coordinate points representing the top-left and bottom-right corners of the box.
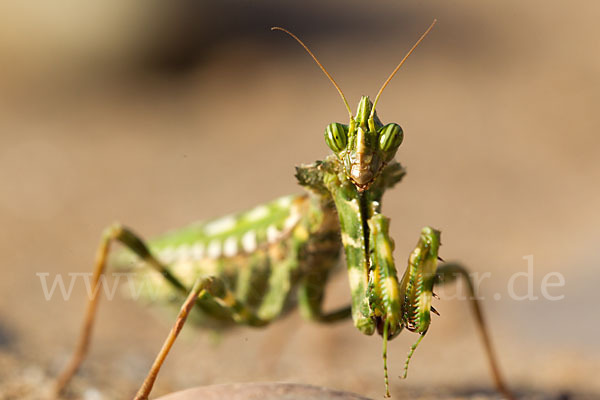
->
(116, 194), (341, 328)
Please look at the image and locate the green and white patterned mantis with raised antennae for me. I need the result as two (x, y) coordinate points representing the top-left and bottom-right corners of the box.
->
(56, 21), (512, 399)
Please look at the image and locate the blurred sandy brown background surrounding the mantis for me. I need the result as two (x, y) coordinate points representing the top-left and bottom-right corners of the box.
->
(0, 0), (600, 398)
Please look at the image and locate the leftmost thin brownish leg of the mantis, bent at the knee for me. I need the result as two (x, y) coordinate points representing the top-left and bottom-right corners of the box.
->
(54, 223), (187, 397)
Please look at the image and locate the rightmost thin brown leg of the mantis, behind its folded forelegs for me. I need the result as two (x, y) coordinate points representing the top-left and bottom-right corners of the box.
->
(435, 263), (515, 400)
